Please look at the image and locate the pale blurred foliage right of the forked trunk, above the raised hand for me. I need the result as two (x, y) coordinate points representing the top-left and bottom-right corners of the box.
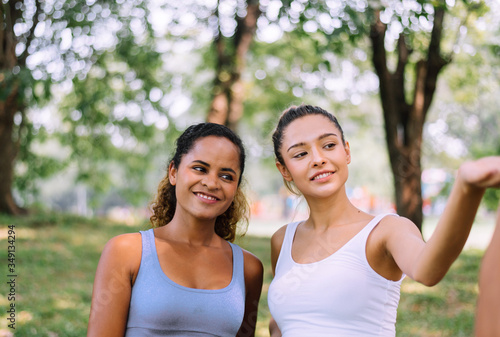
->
(424, 7), (500, 210)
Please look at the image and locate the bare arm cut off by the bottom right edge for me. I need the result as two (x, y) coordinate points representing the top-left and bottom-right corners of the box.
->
(475, 207), (500, 337)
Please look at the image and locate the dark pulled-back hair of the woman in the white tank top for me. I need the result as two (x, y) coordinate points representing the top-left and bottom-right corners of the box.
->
(272, 104), (346, 195)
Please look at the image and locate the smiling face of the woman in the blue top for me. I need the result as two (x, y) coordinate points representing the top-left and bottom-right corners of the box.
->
(169, 136), (241, 220)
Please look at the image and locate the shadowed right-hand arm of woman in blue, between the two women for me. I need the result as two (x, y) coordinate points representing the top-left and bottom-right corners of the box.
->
(236, 251), (264, 337)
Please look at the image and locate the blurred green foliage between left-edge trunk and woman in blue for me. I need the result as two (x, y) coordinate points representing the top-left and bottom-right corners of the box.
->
(6, 0), (184, 209)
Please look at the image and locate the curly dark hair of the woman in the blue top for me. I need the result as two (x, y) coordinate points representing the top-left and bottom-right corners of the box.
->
(150, 123), (249, 242)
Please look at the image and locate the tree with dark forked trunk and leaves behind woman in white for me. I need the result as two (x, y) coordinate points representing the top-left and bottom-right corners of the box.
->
(266, 0), (486, 229)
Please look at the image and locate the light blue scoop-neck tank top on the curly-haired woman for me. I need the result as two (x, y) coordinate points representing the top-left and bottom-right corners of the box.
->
(125, 229), (245, 337)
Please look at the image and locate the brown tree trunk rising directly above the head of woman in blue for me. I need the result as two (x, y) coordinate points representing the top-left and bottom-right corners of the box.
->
(207, 0), (261, 130)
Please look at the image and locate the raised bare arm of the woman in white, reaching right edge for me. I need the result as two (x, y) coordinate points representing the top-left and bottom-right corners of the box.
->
(387, 157), (500, 286)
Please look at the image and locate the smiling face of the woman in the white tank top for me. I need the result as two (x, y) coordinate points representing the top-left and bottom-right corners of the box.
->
(276, 115), (351, 198)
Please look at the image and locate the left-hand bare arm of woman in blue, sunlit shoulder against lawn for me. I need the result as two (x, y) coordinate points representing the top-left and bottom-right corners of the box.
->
(87, 233), (142, 337)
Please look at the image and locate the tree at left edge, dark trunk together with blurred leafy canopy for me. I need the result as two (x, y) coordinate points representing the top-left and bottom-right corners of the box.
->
(0, 0), (168, 214)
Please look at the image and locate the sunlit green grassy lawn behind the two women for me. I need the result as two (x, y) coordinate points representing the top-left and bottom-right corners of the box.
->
(0, 215), (483, 337)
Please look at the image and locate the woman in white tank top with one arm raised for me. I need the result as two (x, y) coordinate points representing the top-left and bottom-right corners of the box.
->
(268, 105), (500, 337)
